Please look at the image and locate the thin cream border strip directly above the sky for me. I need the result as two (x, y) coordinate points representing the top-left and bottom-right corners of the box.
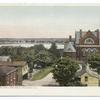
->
(0, 3), (100, 6)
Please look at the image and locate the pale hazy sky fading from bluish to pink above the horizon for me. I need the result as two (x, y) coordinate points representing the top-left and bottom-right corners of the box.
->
(0, 6), (100, 38)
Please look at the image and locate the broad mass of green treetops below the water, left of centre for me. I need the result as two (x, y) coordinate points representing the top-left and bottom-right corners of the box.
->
(0, 44), (55, 72)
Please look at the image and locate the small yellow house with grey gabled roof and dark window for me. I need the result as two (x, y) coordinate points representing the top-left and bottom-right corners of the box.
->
(76, 64), (100, 86)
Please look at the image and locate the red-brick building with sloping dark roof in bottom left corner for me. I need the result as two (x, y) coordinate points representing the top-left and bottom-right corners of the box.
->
(0, 66), (17, 86)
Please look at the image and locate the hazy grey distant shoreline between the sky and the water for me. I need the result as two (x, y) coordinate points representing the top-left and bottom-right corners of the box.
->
(0, 38), (75, 44)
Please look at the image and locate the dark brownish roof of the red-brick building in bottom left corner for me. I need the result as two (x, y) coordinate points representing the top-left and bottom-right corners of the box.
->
(0, 66), (17, 76)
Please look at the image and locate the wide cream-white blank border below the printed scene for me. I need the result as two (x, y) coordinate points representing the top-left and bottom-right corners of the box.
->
(0, 86), (100, 97)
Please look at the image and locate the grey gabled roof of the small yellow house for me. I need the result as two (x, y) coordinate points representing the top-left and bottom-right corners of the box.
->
(76, 64), (100, 78)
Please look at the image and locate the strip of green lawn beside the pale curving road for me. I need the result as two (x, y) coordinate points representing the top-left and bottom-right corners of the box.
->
(32, 67), (53, 81)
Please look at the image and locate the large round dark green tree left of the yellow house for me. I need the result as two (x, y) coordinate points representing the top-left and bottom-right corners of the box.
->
(53, 58), (80, 86)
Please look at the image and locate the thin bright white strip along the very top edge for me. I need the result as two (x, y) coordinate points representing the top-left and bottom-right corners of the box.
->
(0, 0), (100, 3)
